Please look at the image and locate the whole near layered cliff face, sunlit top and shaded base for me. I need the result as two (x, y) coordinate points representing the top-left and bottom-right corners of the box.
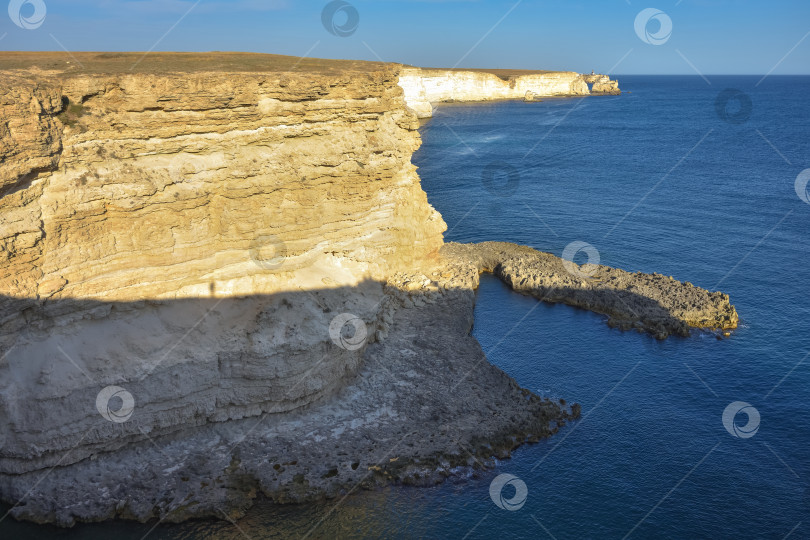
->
(0, 59), (445, 473)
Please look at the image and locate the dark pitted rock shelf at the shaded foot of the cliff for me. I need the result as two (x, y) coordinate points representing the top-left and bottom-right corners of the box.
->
(0, 274), (580, 525)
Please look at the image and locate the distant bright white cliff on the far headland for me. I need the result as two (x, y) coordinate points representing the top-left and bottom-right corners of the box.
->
(399, 68), (618, 118)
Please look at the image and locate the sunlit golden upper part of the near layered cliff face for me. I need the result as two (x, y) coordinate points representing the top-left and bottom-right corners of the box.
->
(0, 65), (444, 306)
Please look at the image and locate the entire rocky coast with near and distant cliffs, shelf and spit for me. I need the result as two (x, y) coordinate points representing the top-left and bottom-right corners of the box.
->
(0, 53), (737, 526)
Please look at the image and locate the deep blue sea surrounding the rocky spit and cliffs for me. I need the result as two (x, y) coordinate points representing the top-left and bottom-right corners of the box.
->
(3, 76), (810, 540)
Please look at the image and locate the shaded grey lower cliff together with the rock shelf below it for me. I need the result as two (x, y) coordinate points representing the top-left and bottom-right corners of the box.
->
(0, 280), (580, 525)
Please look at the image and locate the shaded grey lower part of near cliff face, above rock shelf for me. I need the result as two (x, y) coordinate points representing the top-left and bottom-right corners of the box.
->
(0, 281), (392, 473)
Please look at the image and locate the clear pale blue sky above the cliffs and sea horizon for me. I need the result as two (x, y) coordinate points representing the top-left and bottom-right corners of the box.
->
(0, 0), (810, 74)
